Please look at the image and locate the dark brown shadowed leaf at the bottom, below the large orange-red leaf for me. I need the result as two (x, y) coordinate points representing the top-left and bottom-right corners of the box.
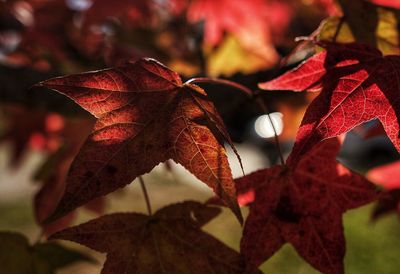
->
(51, 201), (261, 274)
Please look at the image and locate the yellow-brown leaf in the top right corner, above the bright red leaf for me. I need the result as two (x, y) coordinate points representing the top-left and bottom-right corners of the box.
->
(317, 0), (400, 54)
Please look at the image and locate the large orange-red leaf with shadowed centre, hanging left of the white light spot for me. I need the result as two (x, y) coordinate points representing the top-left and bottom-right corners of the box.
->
(40, 59), (241, 223)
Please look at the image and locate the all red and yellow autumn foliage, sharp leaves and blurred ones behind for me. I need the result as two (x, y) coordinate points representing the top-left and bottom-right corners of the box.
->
(0, 0), (400, 274)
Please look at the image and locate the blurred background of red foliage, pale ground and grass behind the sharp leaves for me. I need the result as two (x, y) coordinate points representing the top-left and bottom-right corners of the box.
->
(0, 0), (400, 274)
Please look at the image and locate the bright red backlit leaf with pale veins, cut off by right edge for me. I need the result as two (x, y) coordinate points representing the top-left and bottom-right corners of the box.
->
(260, 42), (400, 161)
